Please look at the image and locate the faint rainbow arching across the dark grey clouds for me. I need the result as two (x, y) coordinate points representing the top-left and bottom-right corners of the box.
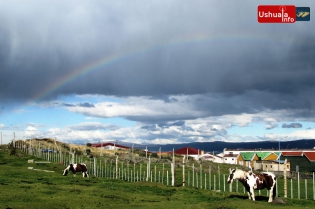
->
(29, 34), (284, 102)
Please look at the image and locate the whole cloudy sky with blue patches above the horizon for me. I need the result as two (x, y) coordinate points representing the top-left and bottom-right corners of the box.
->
(0, 0), (315, 144)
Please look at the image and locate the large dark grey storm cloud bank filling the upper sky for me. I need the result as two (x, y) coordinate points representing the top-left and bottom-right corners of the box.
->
(0, 1), (315, 119)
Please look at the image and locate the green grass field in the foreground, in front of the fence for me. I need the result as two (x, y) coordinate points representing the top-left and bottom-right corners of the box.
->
(0, 148), (315, 209)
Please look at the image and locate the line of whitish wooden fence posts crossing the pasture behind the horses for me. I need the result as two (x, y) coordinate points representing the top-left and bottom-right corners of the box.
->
(17, 146), (315, 200)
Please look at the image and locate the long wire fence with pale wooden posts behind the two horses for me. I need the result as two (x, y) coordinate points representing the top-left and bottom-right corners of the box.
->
(16, 143), (315, 200)
